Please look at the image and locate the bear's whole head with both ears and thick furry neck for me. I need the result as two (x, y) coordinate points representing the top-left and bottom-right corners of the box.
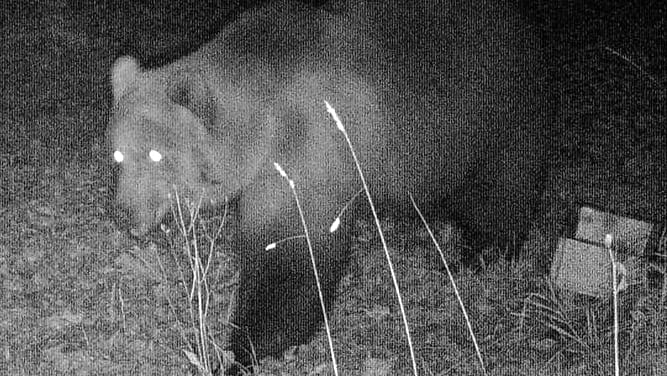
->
(109, 57), (270, 236)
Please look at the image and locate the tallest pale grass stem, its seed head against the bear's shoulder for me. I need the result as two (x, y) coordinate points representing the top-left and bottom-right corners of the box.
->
(324, 101), (418, 376)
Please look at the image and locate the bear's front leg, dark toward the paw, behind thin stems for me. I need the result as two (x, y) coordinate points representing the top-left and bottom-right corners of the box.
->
(231, 179), (350, 366)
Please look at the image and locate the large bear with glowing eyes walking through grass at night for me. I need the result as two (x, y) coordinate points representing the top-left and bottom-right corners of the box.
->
(108, 0), (547, 372)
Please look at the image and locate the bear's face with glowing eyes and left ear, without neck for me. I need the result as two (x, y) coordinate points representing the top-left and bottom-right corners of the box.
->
(109, 58), (213, 236)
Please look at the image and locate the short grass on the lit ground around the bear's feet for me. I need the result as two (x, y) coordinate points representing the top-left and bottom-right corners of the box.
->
(0, 152), (667, 375)
